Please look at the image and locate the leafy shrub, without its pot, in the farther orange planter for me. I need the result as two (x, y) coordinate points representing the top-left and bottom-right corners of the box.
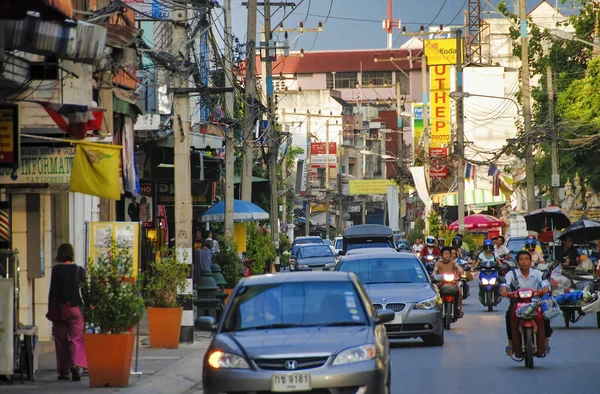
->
(144, 248), (191, 308)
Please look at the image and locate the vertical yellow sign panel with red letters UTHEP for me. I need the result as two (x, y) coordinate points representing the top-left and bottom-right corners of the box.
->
(429, 66), (451, 148)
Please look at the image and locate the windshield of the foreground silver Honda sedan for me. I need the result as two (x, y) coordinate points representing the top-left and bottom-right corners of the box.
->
(223, 281), (367, 331)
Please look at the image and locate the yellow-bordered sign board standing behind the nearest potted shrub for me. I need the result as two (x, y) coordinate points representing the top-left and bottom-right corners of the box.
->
(88, 222), (140, 277)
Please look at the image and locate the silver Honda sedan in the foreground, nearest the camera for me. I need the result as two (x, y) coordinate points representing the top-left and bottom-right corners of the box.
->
(196, 272), (394, 394)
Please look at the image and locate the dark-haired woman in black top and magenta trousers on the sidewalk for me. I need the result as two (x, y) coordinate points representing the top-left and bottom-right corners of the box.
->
(47, 244), (87, 381)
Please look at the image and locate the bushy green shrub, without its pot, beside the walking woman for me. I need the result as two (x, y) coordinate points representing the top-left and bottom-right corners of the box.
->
(81, 242), (144, 334)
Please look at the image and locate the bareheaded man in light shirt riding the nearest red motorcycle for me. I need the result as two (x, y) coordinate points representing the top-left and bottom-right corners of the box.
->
(501, 250), (552, 356)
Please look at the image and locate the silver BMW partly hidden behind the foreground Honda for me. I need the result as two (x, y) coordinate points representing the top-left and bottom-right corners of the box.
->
(336, 252), (444, 346)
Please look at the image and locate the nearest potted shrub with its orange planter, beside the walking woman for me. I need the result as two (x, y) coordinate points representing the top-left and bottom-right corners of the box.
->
(82, 242), (144, 387)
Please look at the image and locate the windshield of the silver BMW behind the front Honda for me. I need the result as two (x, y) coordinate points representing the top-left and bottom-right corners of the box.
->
(338, 256), (429, 285)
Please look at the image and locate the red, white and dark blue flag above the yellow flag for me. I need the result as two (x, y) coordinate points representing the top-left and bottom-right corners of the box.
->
(37, 101), (104, 138)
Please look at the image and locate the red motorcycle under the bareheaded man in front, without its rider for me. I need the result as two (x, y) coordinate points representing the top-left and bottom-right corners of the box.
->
(508, 289), (546, 369)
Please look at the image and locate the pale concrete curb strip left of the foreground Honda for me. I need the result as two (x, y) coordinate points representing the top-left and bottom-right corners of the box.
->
(119, 338), (211, 394)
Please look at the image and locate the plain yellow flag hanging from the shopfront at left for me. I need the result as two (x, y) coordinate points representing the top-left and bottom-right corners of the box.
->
(71, 142), (123, 200)
